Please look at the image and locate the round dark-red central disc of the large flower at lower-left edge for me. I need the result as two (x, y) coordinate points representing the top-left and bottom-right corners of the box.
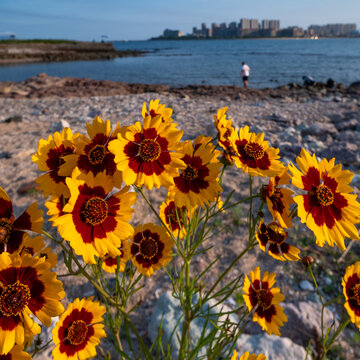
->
(0, 280), (31, 316)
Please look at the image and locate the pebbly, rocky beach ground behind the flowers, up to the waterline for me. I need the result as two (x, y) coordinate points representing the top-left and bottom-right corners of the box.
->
(0, 75), (360, 360)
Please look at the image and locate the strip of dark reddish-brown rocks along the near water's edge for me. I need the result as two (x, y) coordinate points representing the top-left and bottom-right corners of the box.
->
(0, 73), (360, 100)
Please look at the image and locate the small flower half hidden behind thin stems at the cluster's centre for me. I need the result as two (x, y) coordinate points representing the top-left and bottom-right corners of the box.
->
(159, 198), (193, 239)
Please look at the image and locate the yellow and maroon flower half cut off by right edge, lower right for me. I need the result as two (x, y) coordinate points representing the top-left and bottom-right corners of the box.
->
(341, 261), (360, 330)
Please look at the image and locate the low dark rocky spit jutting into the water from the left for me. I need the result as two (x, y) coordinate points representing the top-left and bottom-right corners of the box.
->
(0, 41), (144, 65)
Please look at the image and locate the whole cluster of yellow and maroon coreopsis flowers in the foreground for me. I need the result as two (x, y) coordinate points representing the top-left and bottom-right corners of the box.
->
(0, 99), (360, 360)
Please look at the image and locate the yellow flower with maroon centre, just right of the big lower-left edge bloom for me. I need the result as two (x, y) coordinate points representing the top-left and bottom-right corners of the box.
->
(52, 297), (106, 360)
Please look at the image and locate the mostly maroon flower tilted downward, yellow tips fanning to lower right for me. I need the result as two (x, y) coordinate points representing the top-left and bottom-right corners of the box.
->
(256, 220), (300, 261)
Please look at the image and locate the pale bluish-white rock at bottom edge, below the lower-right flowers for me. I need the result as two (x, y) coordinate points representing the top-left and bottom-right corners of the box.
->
(236, 333), (310, 360)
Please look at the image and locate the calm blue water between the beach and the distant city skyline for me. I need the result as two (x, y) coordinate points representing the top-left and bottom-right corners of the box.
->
(0, 39), (360, 88)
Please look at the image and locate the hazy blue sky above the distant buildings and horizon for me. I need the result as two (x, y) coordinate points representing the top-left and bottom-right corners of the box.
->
(0, 0), (360, 40)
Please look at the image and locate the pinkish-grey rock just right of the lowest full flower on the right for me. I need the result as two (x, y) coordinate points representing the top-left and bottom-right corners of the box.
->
(280, 300), (335, 345)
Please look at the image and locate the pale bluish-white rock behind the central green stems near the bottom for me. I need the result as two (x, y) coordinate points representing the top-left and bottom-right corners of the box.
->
(148, 291), (238, 359)
